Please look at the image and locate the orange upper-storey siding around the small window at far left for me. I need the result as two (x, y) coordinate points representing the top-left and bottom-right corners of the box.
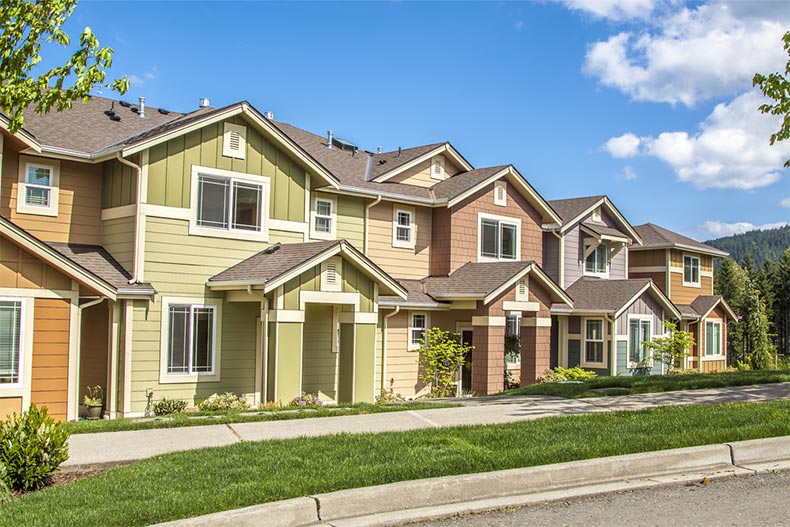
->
(0, 150), (101, 245)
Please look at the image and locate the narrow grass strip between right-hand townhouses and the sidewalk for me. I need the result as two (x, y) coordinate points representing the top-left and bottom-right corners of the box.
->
(504, 370), (790, 399)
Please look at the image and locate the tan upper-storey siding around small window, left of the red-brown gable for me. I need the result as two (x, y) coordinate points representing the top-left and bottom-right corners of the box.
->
(368, 201), (432, 279)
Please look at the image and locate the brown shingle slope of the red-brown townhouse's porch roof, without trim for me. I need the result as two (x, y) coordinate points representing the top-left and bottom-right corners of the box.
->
(423, 261), (534, 295)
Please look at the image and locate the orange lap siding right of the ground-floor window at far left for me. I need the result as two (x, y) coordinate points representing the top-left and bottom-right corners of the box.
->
(30, 298), (71, 420)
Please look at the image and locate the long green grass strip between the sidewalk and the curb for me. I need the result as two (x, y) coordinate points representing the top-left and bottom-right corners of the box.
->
(0, 400), (790, 527)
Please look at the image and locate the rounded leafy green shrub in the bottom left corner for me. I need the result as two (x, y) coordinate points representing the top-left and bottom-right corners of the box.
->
(0, 404), (69, 491)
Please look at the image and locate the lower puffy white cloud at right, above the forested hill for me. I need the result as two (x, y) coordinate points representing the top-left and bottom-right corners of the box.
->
(603, 90), (790, 190)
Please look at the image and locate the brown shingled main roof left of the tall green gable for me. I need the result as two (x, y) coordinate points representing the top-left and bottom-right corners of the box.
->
(20, 96), (183, 153)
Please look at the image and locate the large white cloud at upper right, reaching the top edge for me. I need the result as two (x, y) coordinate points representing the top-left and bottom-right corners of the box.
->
(580, 0), (790, 106)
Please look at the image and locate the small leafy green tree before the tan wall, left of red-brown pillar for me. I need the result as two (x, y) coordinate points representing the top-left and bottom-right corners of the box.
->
(415, 328), (472, 397)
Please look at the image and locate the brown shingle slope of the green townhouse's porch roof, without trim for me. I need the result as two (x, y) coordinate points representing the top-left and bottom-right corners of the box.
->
(209, 240), (343, 282)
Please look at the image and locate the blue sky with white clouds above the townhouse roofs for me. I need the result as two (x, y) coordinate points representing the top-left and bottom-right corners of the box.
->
(57, 0), (790, 239)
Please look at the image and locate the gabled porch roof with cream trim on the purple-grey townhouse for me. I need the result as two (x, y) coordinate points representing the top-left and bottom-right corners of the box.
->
(566, 276), (681, 318)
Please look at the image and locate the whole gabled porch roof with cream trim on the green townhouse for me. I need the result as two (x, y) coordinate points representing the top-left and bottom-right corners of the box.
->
(206, 240), (406, 298)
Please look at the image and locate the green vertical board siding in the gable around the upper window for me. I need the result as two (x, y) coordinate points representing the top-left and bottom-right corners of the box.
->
(148, 117), (306, 222)
